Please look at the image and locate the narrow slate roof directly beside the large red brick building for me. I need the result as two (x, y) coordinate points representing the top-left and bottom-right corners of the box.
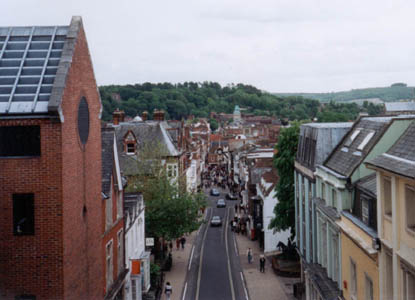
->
(101, 128), (114, 197)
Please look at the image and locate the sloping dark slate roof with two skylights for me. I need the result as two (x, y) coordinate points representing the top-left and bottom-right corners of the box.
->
(323, 117), (393, 177)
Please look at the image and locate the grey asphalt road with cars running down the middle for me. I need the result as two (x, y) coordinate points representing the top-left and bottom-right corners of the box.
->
(182, 189), (249, 300)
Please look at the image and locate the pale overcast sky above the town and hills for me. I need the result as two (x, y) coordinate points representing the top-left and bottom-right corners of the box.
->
(0, 0), (415, 92)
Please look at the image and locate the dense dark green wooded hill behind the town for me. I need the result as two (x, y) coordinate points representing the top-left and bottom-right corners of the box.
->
(100, 82), (386, 122)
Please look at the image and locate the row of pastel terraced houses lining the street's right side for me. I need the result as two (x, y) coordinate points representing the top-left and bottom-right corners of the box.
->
(295, 114), (415, 300)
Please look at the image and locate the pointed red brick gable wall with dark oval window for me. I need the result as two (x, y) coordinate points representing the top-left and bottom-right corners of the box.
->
(62, 24), (104, 299)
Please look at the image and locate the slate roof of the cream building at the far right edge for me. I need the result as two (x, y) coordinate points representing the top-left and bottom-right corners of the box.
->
(367, 121), (415, 178)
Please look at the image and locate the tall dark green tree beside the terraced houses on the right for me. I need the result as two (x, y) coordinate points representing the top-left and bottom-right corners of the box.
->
(268, 122), (300, 236)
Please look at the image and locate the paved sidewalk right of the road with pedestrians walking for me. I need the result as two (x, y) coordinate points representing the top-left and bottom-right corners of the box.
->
(235, 233), (299, 300)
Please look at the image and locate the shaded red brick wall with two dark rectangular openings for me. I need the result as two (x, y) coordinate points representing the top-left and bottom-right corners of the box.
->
(0, 119), (63, 299)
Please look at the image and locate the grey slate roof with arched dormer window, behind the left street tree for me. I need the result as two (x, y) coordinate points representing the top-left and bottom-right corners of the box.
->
(112, 121), (180, 176)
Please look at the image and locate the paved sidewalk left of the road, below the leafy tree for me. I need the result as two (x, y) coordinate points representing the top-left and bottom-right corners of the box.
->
(161, 231), (197, 300)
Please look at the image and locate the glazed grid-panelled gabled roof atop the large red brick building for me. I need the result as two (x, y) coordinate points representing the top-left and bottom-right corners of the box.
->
(0, 17), (82, 115)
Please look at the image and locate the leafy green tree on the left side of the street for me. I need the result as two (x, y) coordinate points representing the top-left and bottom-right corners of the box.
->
(128, 144), (206, 240)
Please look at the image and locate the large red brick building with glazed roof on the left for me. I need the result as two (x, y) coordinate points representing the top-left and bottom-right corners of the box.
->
(0, 17), (104, 299)
